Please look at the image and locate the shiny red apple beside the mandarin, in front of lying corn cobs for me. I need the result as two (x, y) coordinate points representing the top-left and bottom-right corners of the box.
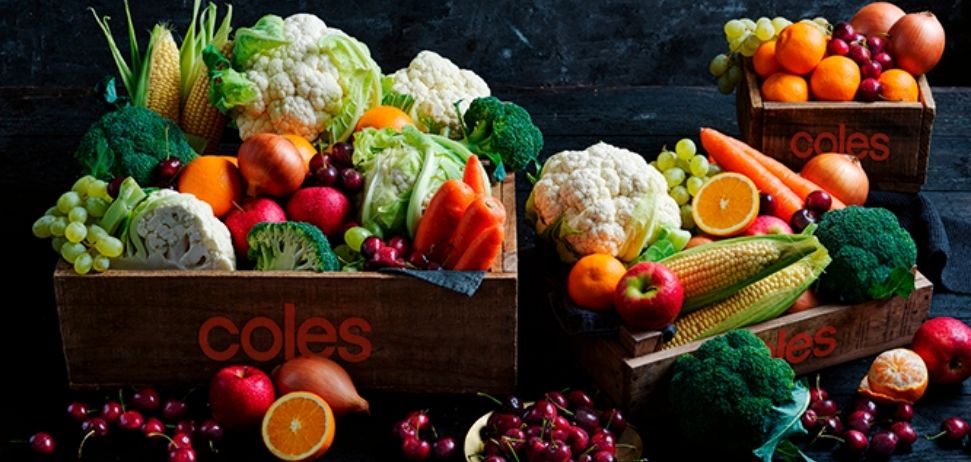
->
(614, 262), (684, 329)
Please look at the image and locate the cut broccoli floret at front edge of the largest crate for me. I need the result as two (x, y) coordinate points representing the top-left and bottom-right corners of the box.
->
(246, 221), (341, 272)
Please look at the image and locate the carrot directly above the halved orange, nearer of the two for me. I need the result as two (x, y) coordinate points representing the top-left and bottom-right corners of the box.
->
(701, 128), (803, 223)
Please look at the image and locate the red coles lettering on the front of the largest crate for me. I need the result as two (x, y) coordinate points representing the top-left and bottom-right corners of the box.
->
(199, 303), (371, 363)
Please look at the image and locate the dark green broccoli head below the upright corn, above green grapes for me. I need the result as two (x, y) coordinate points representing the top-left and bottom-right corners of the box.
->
(74, 106), (196, 185)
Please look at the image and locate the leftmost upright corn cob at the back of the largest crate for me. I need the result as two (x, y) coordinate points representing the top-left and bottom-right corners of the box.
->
(142, 24), (182, 122)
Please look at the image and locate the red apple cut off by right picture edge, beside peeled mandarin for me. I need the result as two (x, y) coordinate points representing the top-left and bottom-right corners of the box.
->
(911, 317), (971, 384)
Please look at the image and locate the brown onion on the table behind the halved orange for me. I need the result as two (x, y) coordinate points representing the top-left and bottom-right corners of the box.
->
(273, 356), (370, 417)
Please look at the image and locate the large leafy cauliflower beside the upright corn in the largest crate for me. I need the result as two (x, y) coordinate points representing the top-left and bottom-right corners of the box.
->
(206, 13), (381, 143)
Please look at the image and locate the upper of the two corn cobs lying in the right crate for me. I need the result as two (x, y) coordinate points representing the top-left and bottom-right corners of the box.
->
(660, 234), (822, 314)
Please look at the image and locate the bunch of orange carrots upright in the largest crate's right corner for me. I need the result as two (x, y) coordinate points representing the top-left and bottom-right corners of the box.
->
(414, 156), (506, 271)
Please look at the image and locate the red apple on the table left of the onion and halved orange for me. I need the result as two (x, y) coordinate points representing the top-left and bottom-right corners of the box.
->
(209, 365), (276, 429)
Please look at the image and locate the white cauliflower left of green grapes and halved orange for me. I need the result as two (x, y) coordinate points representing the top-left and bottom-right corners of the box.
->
(526, 142), (681, 262)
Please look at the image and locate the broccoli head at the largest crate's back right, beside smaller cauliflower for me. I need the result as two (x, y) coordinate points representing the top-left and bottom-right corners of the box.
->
(463, 96), (543, 177)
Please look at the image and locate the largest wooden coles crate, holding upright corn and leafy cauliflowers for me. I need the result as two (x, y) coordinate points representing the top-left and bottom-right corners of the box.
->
(54, 177), (518, 393)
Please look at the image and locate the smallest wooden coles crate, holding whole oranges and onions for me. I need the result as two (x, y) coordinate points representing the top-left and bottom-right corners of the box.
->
(735, 60), (936, 192)
